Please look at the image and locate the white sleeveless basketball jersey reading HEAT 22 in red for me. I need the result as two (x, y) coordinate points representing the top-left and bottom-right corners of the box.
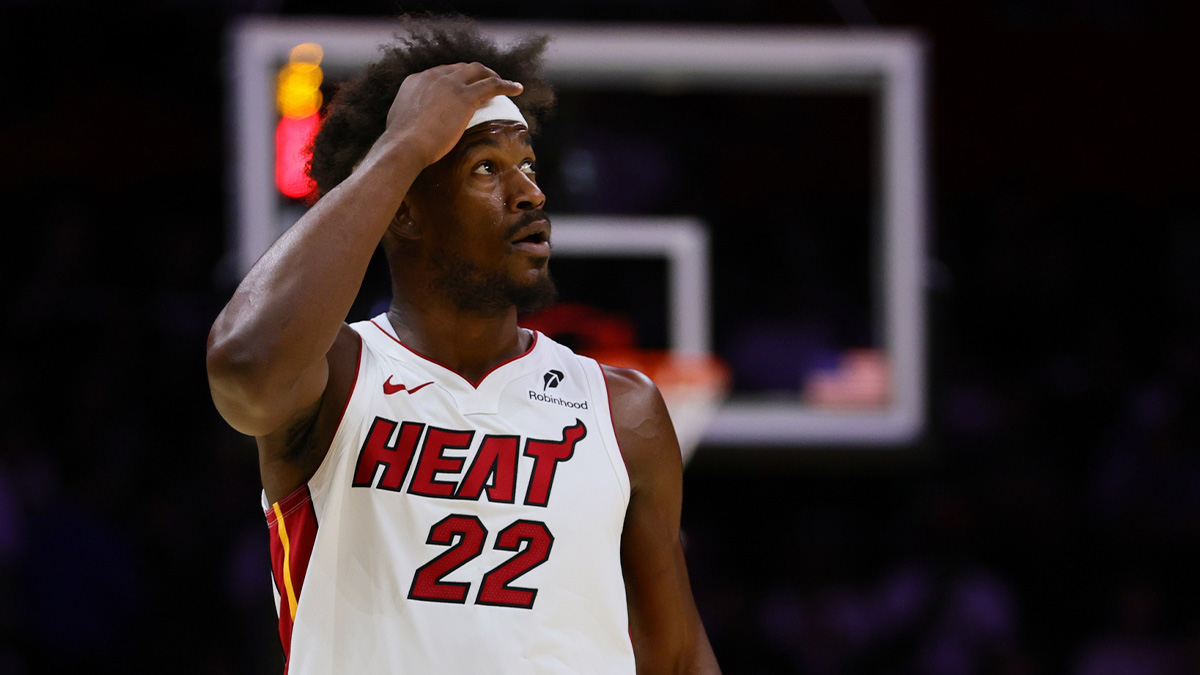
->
(264, 315), (634, 675)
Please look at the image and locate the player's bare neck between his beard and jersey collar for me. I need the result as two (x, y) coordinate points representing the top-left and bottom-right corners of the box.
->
(388, 295), (532, 384)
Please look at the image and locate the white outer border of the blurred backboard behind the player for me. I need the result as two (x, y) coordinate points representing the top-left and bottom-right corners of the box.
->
(226, 18), (928, 448)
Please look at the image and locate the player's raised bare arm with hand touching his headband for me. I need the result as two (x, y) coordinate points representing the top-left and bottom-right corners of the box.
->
(208, 64), (521, 436)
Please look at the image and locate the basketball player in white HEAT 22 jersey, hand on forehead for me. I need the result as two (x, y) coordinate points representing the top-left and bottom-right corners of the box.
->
(208, 18), (719, 675)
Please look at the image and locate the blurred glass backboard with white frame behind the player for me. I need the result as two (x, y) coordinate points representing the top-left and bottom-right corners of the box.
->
(228, 19), (926, 448)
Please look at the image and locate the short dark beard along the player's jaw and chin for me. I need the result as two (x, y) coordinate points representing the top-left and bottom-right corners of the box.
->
(430, 252), (558, 316)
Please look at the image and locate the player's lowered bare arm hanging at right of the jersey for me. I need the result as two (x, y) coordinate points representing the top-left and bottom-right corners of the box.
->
(605, 366), (720, 675)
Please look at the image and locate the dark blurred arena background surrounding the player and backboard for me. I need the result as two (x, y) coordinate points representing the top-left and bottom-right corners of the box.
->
(0, 0), (1200, 675)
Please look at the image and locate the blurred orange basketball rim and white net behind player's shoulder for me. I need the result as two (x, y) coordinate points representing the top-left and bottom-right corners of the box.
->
(588, 350), (731, 465)
